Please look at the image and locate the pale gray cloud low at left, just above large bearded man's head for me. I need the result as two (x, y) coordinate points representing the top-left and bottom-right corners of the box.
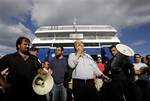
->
(0, 23), (34, 47)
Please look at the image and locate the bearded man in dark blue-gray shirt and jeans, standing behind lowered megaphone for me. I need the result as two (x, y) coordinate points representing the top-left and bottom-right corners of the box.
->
(49, 46), (68, 101)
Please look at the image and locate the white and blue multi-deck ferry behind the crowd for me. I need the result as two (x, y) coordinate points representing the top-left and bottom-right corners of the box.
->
(32, 24), (120, 61)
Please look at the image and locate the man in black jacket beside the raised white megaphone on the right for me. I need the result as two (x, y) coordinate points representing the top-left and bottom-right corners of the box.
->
(104, 45), (136, 101)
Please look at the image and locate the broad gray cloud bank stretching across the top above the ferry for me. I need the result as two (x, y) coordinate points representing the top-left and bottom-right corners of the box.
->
(32, 0), (150, 26)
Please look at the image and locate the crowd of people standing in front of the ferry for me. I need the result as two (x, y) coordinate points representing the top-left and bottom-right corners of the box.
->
(0, 36), (150, 101)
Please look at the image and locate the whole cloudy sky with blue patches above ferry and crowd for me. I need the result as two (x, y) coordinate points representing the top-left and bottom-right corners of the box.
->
(0, 0), (150, 55)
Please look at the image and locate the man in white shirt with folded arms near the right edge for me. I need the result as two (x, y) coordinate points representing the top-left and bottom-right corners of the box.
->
(133, 54), (150, 101)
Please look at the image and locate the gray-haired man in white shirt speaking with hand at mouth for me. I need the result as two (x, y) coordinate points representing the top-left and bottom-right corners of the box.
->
(68, 40), (109, 101)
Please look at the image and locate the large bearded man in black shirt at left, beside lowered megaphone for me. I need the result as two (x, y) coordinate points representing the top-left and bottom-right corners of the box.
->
(0, 37), (46, 101)
